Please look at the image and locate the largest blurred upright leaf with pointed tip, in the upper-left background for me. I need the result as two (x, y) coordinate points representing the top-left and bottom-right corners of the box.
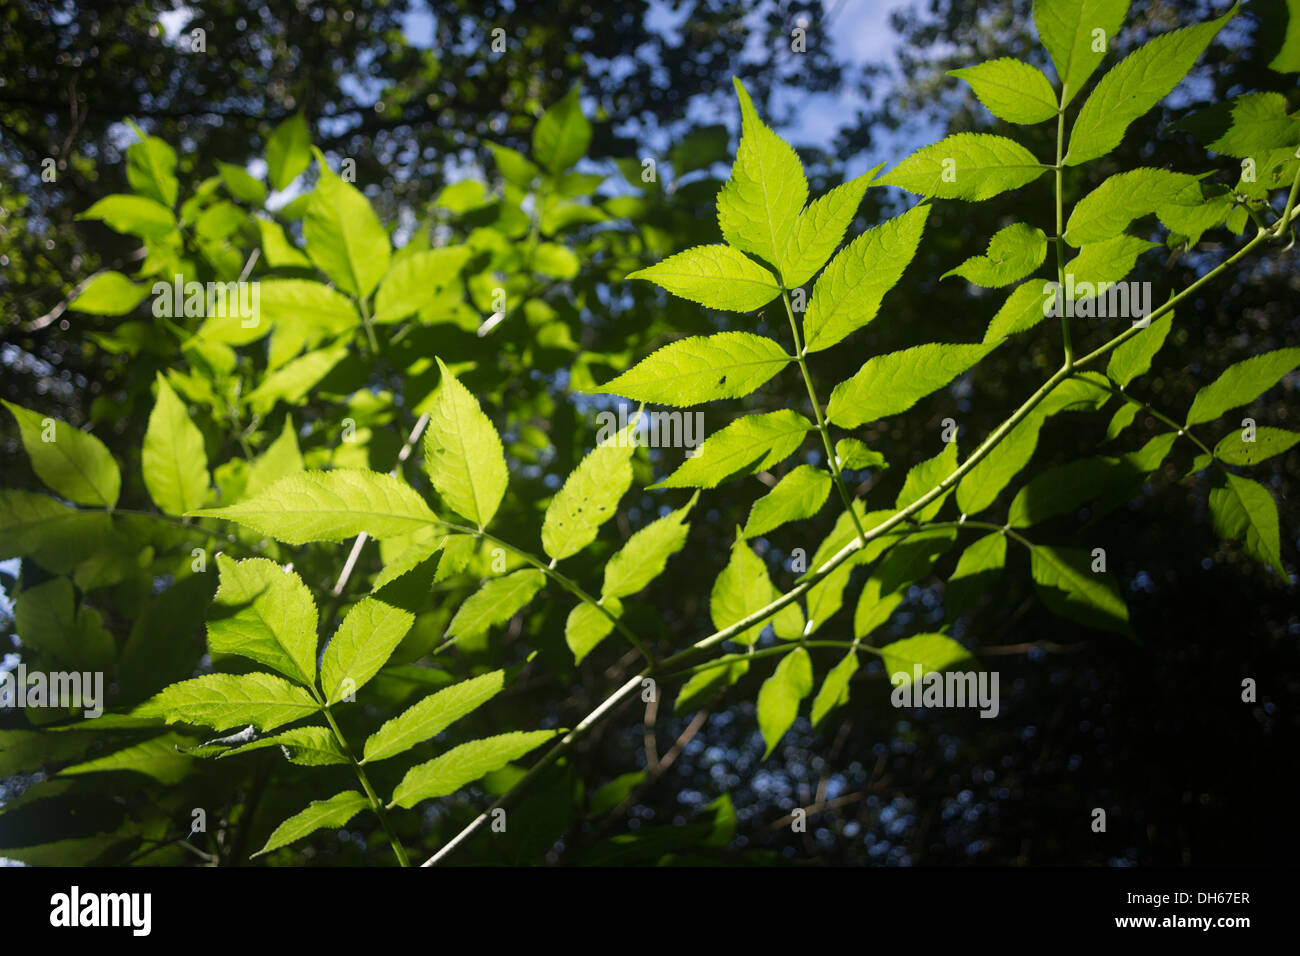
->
(303, 157), (390, 298)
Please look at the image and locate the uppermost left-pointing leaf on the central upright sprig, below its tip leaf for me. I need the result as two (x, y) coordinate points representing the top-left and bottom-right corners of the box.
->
(628, 243), (781, 312)
